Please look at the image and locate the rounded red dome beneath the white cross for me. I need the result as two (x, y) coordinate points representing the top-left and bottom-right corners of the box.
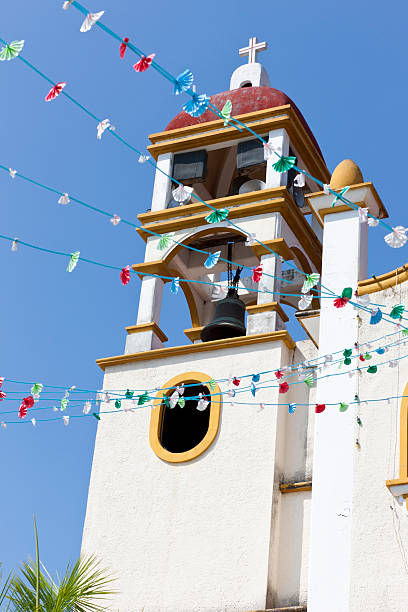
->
(165, 87), (324, 159)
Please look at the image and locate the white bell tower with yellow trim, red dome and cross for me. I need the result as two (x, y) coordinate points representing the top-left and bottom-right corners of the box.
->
(83, 38), (330, 612)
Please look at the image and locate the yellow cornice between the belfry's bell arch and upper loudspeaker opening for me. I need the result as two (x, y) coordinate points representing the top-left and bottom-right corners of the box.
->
(137, 187), (322, 270)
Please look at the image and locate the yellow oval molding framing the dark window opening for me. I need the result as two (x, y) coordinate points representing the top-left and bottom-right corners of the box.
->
(149, 372), (222, 463)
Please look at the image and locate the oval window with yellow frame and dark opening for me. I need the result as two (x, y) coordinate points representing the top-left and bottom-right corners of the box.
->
(150, 372), (221, 463)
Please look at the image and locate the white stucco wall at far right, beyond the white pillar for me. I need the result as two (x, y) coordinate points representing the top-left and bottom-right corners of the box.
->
(349, 283), (408, 612)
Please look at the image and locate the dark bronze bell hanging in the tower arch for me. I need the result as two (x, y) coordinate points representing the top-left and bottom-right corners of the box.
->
(201, 289), (246, 342)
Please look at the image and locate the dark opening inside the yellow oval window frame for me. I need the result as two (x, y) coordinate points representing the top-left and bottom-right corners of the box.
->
(159, 383), (211, 453)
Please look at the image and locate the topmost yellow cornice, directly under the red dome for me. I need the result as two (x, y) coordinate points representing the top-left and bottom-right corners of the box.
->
(147, 104), (330, 183)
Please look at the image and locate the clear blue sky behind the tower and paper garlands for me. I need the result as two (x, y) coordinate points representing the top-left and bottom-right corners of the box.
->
(0, 0), (408, 584)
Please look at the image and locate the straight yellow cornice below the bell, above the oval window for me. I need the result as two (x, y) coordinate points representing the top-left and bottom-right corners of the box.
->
(96, 330), (296, 370)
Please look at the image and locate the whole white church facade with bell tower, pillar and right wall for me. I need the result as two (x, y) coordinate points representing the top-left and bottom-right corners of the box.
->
(82, 39), (408, 612)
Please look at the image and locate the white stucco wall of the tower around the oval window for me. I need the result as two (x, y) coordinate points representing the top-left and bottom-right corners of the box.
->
(83, 342), (289, 612)
